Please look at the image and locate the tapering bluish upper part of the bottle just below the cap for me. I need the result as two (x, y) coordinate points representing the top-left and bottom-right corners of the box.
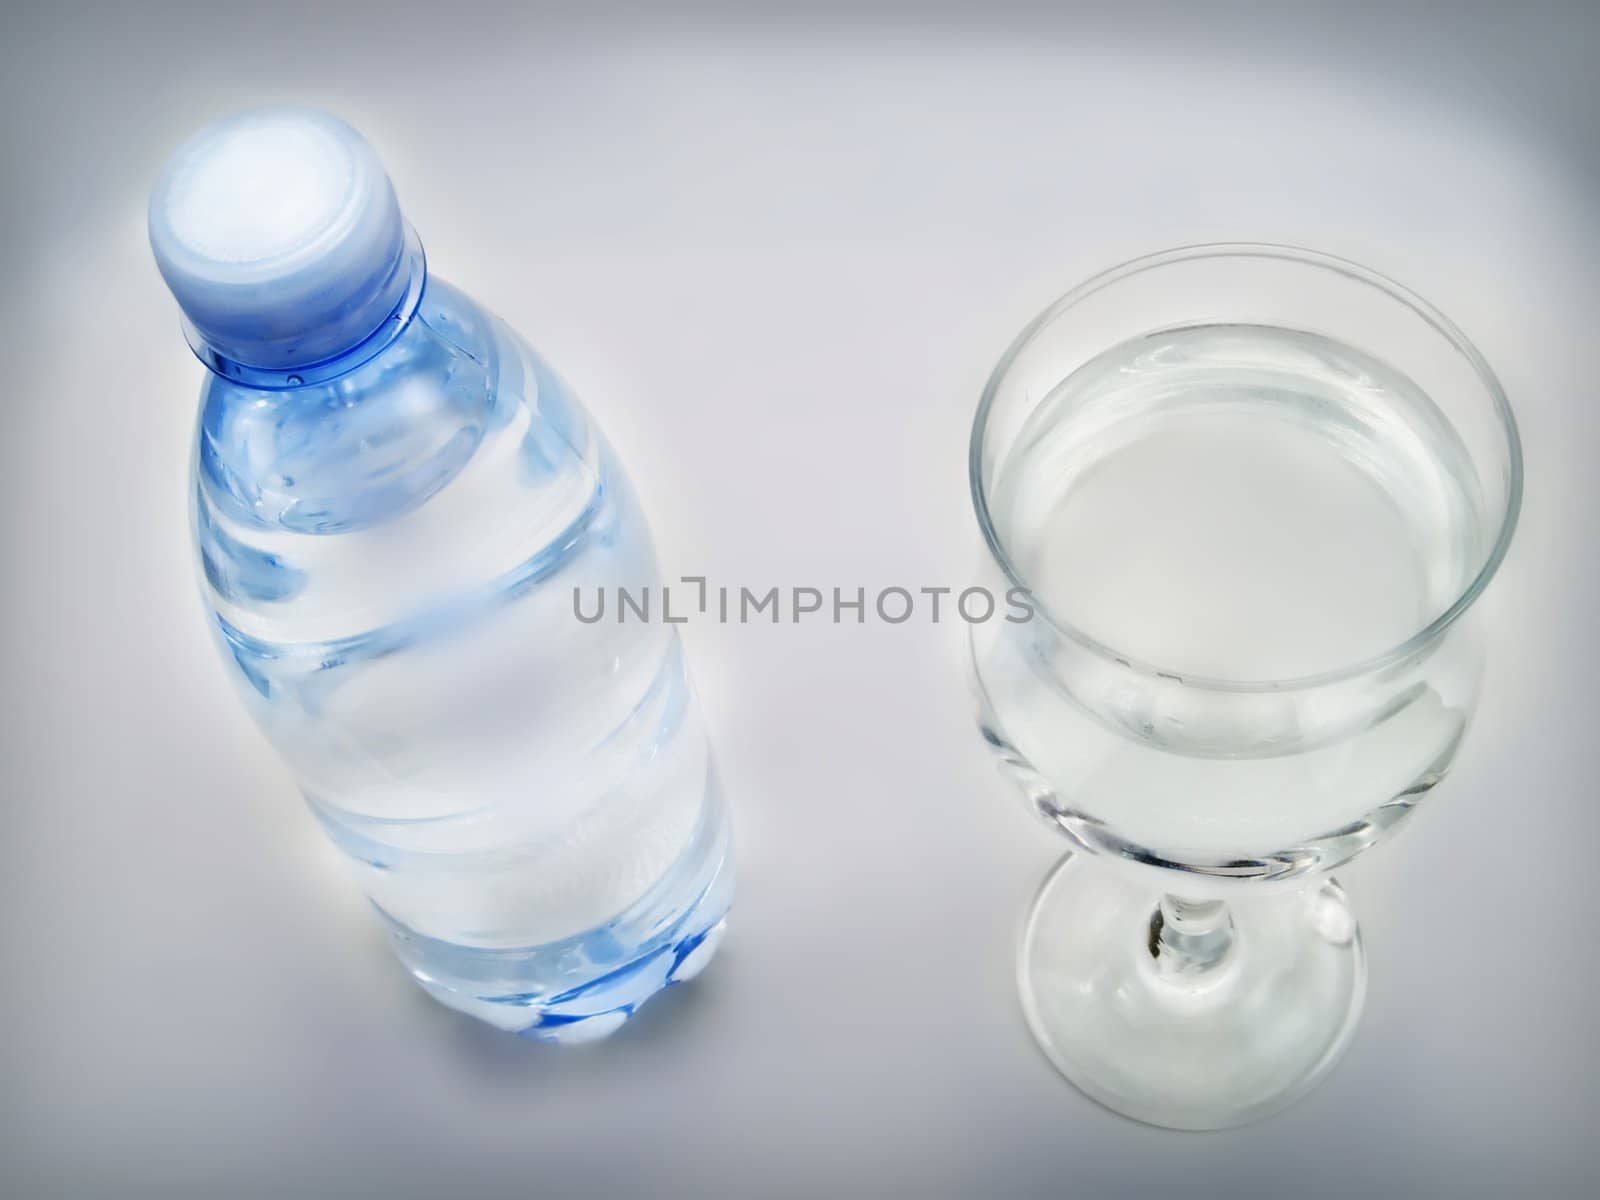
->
(194, 280), (654, 642)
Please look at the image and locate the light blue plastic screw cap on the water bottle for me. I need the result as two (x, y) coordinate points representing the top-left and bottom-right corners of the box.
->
(150, 107), (411, 371)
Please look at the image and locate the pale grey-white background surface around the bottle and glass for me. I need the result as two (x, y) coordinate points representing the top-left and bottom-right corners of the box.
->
(0, 0), (1600, 1197)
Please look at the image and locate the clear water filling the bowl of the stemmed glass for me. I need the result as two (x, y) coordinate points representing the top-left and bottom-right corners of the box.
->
(981, 323), (1488, 862)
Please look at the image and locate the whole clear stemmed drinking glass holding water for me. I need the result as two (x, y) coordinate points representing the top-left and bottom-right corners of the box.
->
(971, 245), (1522, 1130)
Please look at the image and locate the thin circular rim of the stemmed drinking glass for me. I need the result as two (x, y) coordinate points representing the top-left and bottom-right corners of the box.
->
(966, 242), (1523, 693)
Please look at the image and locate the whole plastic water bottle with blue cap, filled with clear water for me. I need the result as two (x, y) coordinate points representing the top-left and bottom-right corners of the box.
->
(149, 109), (733, 1042)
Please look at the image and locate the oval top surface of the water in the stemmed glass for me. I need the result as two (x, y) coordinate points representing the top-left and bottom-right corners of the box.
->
(994, 325), (1483, 680)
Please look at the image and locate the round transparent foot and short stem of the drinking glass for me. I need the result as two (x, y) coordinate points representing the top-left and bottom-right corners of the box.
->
(1018, 854), (1366, 1130)
